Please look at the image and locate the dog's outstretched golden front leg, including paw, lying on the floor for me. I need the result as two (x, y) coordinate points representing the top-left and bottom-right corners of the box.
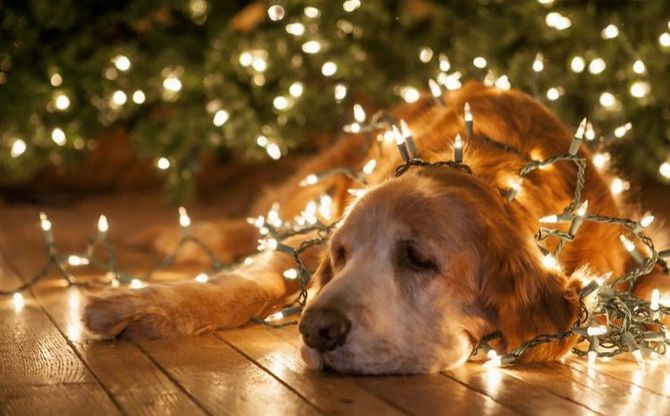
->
(83, 239), (321, 339)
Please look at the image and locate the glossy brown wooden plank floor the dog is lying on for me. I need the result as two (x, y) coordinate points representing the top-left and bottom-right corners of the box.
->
(0, 189), (670, 416)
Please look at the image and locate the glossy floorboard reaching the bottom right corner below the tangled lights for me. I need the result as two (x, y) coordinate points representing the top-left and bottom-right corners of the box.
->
(502, 363), (670, 415)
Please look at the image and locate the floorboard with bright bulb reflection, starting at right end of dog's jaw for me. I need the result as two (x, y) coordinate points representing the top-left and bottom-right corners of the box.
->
(444, 362), (597, 415)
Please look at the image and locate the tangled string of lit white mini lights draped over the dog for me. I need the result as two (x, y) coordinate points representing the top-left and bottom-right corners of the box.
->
(0, 85), (670, 367)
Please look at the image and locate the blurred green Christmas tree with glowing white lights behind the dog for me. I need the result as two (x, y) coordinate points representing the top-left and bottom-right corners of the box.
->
(0, 0), (670, 202)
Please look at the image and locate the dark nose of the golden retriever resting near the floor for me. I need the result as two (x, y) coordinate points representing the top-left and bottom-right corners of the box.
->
(299, 308), (351, 352)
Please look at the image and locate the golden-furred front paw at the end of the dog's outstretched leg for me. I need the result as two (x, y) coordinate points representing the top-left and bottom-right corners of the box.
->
(82, 289), (180, 340)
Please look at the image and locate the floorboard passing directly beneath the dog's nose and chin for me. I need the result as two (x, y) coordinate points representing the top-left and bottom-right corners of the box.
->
(217, 325), (404, 416)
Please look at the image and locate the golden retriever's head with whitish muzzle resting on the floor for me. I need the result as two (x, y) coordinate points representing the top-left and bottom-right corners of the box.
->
(300, 168), (578, 374)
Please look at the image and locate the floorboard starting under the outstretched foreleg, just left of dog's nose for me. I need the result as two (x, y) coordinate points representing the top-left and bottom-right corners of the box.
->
(138, 335), (320, 415)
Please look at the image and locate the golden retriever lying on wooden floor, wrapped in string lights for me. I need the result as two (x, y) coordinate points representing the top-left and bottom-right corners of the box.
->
(83, 83), (663, 374)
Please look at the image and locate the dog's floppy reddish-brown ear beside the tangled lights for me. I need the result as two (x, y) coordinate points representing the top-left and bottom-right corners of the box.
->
(481, 228), (581, 361)
